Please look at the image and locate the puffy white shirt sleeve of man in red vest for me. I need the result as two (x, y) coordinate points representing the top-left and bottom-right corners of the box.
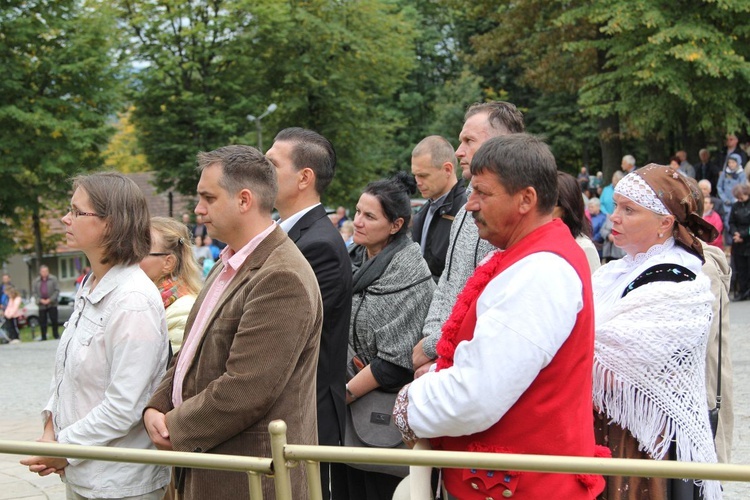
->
(408, 252), (583, 438)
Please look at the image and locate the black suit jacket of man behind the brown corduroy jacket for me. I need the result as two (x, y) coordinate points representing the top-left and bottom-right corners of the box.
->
(289, 205), (352, 446)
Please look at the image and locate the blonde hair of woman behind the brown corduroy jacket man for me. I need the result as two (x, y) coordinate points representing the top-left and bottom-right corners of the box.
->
(151, 217), (202, 295)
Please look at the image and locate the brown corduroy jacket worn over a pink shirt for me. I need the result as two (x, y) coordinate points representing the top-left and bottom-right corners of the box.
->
(147, 227), (323, 500)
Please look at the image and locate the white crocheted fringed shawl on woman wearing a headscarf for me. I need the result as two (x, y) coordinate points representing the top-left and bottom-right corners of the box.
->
(593, 241), (721, 500)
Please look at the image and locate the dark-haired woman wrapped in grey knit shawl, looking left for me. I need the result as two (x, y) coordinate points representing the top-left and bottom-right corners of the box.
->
(346, 172), (435, 500)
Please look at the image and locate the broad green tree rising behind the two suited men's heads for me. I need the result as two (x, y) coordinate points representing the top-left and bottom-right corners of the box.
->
(120, 0), (413, 207)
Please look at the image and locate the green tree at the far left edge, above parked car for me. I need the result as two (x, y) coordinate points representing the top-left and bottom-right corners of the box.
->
(0, 0), (123, 266)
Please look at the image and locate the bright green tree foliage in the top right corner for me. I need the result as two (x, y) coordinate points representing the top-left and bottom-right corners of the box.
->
(557, 0), (750, 161)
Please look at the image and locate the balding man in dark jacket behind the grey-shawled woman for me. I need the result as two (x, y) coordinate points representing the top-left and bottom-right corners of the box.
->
(411, 135), (466, 281)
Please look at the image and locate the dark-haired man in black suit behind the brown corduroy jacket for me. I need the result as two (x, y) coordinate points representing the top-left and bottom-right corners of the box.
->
(266, 127), (352, 499)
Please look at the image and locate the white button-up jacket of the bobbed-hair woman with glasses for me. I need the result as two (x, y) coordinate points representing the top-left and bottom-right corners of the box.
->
(42, 265), (170, 498)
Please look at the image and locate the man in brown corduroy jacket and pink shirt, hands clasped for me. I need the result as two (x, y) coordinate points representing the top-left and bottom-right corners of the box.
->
(144, 146), (323, 500)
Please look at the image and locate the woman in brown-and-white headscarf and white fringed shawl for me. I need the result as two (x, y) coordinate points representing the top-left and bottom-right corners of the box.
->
(592, 164), (721, 500)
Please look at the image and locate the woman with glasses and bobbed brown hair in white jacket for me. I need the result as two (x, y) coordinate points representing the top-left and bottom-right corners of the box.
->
(21, 173), (169, 500)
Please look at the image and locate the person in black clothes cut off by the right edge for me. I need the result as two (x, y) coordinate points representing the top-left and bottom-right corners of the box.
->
(729, 184), (750, 300)
